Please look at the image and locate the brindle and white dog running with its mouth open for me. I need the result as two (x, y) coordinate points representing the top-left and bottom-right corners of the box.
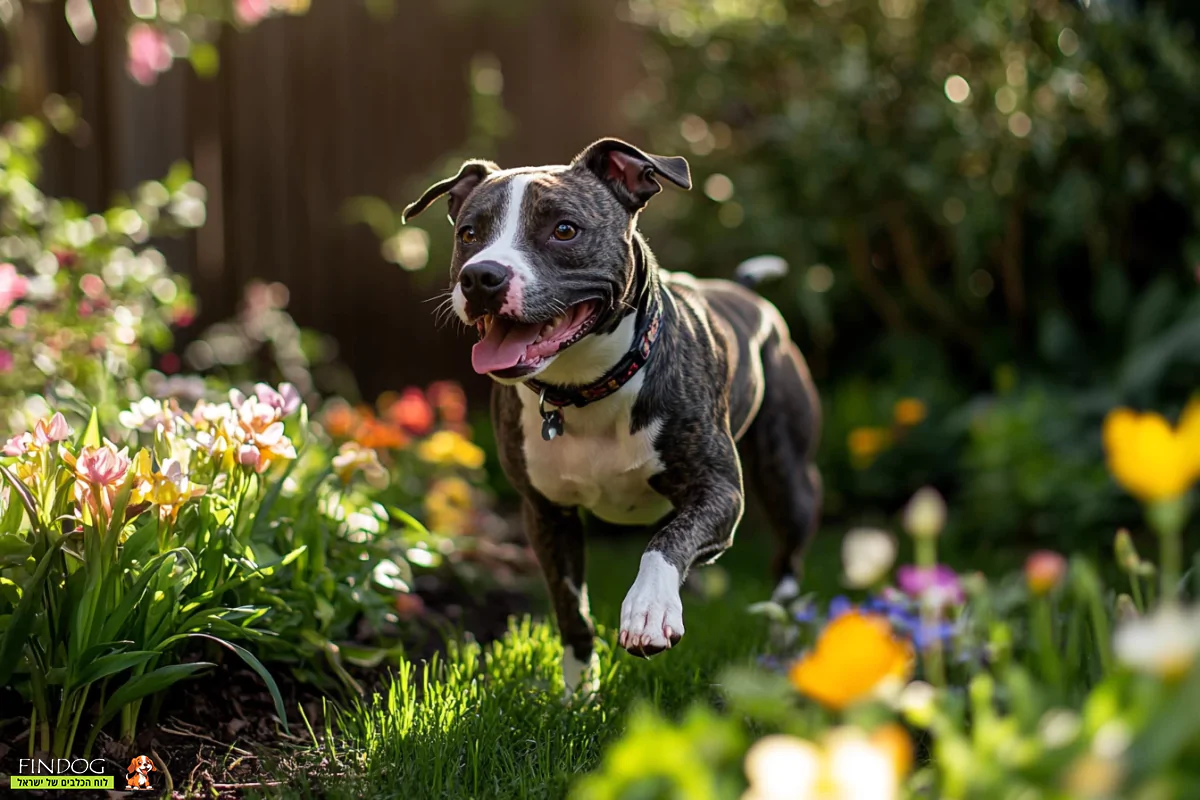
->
(402, 139), (821, 693)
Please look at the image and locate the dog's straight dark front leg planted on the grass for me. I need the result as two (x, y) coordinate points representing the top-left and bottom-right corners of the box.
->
(523, 493), (600, 694)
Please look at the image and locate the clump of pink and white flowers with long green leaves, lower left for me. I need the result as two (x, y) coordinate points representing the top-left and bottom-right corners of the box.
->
(0, 376), (501, 756)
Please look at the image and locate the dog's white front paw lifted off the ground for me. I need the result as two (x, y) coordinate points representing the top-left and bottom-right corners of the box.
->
(618, 552), (683, 657)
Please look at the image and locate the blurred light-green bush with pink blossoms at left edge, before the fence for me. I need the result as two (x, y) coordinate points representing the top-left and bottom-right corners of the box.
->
(0, 119), (205, 428)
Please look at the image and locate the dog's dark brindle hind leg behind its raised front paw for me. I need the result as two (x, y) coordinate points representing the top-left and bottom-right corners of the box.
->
(740, 333), (821, 601)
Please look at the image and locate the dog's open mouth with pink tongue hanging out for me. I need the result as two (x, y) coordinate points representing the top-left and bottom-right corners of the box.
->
(470, 300), (599, 378)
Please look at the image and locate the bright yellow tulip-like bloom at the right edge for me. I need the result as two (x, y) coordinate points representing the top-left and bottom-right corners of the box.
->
(1104, 402), (1200, 503)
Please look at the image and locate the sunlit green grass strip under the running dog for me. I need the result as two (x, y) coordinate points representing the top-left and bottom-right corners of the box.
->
(286, 529), (838, 800)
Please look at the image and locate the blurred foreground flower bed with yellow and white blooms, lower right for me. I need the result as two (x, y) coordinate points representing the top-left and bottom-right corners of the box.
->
(576, 403), (1200, 800)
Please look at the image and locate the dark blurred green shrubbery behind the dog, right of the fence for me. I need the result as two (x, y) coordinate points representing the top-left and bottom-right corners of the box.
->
(624, 0), (1200, 546)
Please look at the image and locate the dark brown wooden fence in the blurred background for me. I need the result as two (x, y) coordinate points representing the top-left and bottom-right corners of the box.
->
(22, 0), (642, 395)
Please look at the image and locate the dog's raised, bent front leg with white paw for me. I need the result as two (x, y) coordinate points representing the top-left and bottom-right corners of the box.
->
(618, 439), (744, 657)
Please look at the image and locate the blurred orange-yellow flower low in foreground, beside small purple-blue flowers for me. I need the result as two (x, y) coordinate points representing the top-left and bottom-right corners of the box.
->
(788, 610), (912, 710)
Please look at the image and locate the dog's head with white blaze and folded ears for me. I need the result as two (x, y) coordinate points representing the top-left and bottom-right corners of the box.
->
(403, 139), (691, 383)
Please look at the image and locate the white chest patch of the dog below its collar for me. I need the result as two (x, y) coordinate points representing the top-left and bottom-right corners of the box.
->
(521, 375), (672, 525)
